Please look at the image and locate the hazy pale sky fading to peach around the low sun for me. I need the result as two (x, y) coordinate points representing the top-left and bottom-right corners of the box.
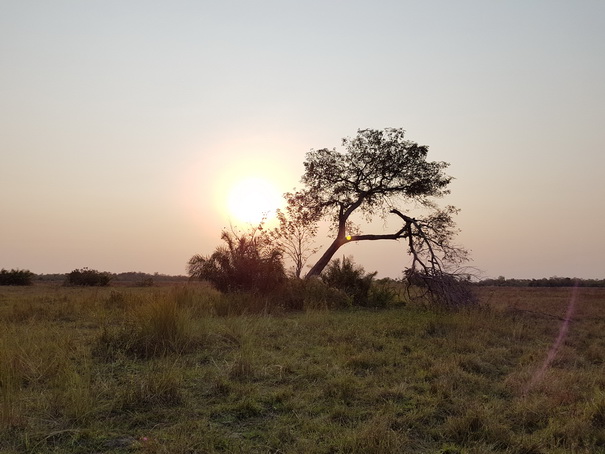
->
(0, 0), (605, 279)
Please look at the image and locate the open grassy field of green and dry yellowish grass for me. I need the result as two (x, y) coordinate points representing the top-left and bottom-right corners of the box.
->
(0, 285), (605, 454)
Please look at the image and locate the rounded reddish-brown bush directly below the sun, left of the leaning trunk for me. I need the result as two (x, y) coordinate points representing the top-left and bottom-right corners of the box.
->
(188, 225), (286, 293)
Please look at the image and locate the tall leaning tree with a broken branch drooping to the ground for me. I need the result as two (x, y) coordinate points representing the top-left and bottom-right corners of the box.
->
(287, 128), (470, 305)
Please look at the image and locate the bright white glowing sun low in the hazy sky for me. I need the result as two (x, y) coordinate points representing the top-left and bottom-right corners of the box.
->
(227, 178), (282, 224)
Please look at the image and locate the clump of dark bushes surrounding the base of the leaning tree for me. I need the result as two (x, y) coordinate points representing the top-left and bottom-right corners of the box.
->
(188, 229), (398, 315)
